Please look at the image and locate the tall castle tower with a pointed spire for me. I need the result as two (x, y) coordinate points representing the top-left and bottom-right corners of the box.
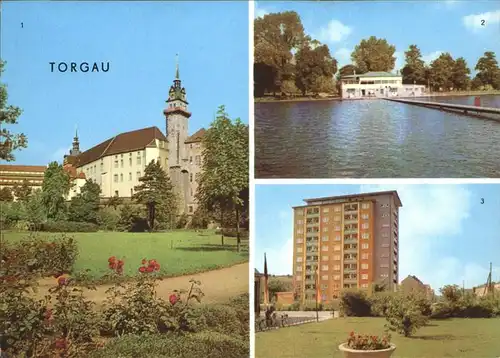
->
(163, 56), (191, 213)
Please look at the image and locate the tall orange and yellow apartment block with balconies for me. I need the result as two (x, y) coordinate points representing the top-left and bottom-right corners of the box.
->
(293, 191), (402, 303)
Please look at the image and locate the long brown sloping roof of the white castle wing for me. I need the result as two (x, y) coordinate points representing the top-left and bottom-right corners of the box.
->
(76, 127), (167, 167)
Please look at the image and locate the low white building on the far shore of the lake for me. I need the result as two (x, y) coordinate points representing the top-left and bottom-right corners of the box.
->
(340, 72), (426, 99)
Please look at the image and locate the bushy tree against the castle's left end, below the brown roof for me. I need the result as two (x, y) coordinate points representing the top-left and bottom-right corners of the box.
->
(68, 179), (101, 224)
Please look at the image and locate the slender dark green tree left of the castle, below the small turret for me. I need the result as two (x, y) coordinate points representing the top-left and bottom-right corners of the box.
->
(42, 162), (71, 220)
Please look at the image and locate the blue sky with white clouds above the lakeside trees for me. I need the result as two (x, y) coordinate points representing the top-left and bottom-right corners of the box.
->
(255, 0), (500, 74)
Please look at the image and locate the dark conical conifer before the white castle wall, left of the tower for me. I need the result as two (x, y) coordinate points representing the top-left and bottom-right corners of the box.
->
(133, 160), (177, 231)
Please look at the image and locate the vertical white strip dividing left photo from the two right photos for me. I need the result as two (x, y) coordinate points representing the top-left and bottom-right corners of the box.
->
(248, 0), (255, 358)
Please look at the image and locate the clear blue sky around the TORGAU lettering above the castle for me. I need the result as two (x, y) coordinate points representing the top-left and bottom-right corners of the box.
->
(1, 1), (249, 165)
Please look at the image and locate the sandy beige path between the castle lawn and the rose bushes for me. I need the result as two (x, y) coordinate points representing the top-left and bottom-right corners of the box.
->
(37, 262), (249, 305)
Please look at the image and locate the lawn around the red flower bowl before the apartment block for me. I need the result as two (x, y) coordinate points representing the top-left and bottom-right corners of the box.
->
(255, 318), (500, 358)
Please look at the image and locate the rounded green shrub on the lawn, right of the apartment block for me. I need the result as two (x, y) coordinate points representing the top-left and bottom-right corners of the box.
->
(385, 293), (427, 337)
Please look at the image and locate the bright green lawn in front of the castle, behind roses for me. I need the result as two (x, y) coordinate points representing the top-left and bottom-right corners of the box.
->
(3, 230), (248, 278)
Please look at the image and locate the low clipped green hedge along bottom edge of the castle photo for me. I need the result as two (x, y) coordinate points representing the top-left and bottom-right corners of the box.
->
(91, 332), (250, 358)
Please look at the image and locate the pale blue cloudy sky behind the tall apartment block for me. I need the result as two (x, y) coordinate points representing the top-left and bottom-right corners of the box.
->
(254, 184), (500, 292)
